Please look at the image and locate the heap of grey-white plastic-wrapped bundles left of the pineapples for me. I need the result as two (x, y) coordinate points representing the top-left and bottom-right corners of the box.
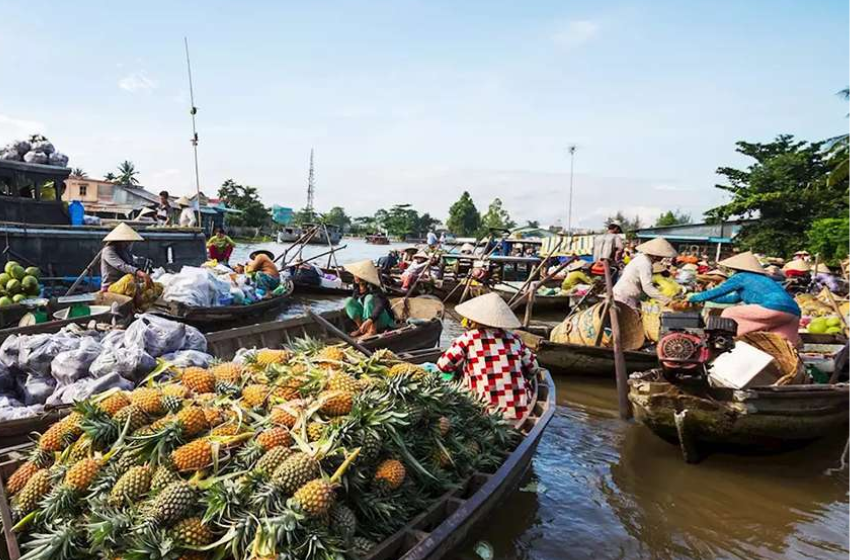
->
(0, 314), (212, 421)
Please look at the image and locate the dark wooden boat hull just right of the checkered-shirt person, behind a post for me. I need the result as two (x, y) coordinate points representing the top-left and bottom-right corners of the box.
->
(516, 331), (658, 380)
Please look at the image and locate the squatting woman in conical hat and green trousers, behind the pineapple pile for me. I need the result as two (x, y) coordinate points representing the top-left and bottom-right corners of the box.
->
(343, 261), (395, 337)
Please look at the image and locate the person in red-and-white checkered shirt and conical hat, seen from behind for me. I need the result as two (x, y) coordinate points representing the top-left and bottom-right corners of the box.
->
(437, 292), (538, 419)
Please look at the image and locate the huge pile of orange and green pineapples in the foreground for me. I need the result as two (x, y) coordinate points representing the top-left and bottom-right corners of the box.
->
(5, 340), (518, 560)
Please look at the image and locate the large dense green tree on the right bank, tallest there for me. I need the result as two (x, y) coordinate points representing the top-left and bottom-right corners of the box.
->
(706, 135), (848, 256)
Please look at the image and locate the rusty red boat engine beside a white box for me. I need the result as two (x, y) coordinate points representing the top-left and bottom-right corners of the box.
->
(656, 311), (737, 375)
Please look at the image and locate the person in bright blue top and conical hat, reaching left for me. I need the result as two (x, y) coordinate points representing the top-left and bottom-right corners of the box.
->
(688, 251), (801, 344)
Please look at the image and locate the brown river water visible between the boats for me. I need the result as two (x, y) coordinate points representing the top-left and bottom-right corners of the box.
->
(235, 240), (850, 560)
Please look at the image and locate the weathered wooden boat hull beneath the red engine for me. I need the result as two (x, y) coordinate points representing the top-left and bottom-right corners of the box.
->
(629, 370), (850, 462)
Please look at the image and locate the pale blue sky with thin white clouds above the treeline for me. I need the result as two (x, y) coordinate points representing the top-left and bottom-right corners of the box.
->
(0, 0), (850, 228)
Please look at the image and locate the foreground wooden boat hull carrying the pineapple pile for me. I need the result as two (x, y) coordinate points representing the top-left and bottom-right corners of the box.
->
(0, 370), (556, 560)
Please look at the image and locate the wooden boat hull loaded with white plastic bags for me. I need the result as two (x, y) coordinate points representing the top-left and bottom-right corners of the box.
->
(150, 284), (293, 332)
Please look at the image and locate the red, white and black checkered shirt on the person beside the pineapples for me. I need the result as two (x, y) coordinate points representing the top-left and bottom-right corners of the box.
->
(437, 328), (537, 419)
